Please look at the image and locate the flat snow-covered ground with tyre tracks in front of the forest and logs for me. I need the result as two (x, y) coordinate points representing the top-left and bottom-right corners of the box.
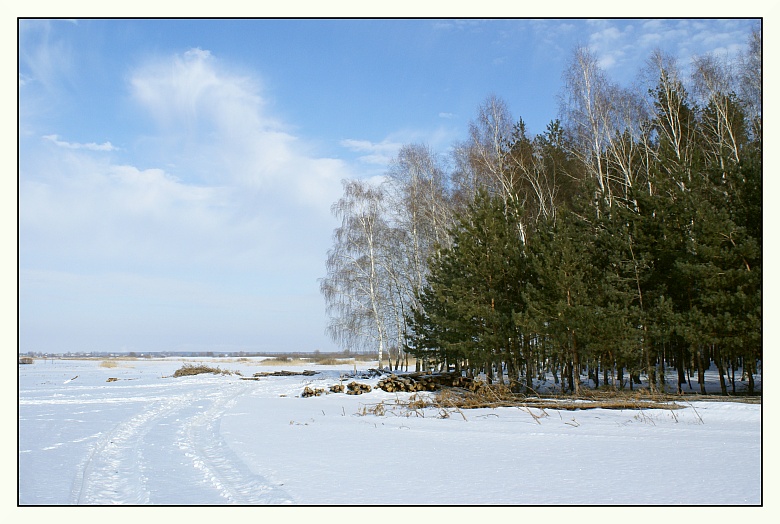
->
(18, 359), (763, 506)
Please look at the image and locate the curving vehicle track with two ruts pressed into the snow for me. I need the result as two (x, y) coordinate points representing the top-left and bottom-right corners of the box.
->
(71, 377), (292, 505)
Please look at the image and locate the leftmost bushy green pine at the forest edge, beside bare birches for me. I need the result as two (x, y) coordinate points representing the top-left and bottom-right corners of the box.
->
(407, 190), (523, 381)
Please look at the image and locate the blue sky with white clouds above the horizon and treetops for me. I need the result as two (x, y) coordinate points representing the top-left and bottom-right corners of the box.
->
(17, 19), (757, 353)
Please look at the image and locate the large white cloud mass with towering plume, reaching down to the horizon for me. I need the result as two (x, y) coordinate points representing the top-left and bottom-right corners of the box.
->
(19, 49), (351, 350)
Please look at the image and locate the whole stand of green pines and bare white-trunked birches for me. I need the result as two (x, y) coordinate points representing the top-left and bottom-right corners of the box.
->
(320, 24), (762, 394)
